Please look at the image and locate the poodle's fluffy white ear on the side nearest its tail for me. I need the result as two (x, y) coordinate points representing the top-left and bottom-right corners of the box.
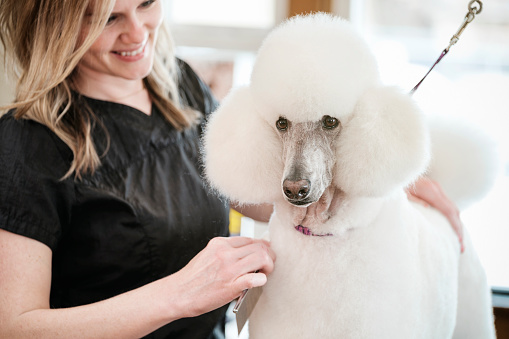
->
(334, 87), (429, 196)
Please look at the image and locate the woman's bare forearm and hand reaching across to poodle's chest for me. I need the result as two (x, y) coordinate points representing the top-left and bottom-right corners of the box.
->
(0, 230), (275, 338)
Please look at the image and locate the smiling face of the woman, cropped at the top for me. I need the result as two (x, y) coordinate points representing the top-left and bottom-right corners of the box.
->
(77, 0), (163, 84)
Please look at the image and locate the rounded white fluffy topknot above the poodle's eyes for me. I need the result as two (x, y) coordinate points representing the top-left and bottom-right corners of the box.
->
(250, 13), (379, 122)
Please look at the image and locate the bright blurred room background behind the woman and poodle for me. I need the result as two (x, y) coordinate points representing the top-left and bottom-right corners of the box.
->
(0, 0), (509, 333)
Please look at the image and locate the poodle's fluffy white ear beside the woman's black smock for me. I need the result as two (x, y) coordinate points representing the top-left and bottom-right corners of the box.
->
(203, 87), (283, 204)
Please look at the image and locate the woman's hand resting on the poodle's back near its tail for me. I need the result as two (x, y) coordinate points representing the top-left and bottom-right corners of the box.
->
(406, 177), (465, 253)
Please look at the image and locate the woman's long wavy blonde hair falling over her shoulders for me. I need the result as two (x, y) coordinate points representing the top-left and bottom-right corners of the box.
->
(0, 0), (197, 178)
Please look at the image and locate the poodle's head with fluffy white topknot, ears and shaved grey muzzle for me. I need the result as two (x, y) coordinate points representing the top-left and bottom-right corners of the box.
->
(204, 13), (429, 206)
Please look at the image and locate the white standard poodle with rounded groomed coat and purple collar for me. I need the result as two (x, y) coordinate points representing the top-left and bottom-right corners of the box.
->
(204, 13), (495, 339)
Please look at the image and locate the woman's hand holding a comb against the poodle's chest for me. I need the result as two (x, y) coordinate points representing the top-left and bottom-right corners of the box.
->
(170, 237), (276, 317)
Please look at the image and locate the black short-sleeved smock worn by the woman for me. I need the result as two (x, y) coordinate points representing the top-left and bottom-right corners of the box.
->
(0, 62), (228, 339)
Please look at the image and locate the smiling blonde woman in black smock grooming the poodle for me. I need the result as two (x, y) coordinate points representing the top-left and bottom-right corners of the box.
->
(0, 0), (274, 338)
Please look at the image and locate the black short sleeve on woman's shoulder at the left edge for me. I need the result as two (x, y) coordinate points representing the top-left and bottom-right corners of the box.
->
(0, 112), (74, 249)
